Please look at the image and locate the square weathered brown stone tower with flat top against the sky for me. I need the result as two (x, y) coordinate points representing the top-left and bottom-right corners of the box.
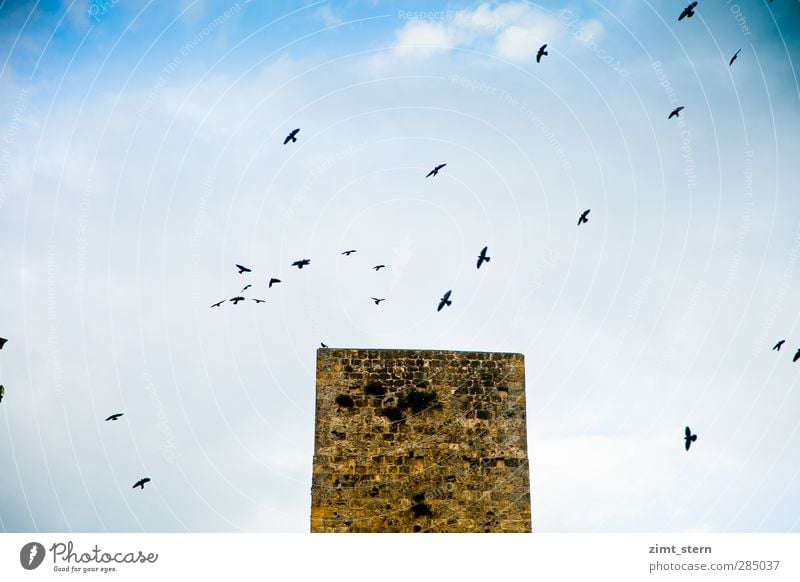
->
(311, 348), (531, 532)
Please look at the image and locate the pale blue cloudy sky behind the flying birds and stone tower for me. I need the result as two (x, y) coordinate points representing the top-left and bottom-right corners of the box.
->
(0, 0), (800, 533)
